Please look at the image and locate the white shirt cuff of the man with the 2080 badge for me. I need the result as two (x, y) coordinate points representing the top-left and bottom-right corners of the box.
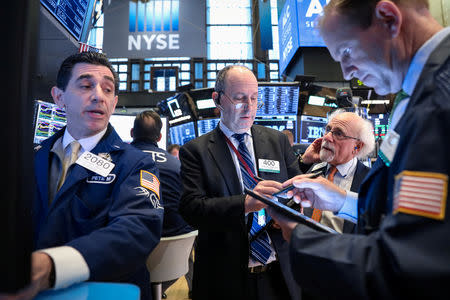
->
(39, 246), (90, 289)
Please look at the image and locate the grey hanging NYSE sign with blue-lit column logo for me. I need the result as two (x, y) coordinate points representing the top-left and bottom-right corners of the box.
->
(103, 0), (206, 58)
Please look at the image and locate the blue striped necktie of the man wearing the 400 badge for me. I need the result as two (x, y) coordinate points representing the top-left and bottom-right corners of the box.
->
(233, 133), (272, 264)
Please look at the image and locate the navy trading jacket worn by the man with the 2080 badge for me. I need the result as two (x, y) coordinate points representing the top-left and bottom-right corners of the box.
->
(33, 125), (163, 299)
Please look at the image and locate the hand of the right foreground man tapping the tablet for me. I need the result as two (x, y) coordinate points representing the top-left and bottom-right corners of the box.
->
(283, 174), (347, 212)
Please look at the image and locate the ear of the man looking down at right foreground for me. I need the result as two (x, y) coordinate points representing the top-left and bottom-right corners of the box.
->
(375, 0), (403, 38)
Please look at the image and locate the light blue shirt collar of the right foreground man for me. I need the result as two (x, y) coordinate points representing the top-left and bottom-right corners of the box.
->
(402, 27), (450, 95)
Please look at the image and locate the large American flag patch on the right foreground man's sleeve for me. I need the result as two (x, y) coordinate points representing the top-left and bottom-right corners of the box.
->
(393, 171), (448, 220)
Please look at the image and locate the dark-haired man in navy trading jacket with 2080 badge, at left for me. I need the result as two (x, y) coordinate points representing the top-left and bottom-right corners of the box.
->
(31, 52), (163, 299)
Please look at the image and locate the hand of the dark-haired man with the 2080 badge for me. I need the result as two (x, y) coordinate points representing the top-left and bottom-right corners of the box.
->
(0, 252), (53, 300)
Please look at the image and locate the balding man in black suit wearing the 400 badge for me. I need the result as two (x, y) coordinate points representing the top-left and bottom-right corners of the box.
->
(180, 66), (300, 300)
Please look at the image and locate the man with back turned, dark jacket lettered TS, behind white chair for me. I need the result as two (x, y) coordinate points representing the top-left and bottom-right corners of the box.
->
(130, 110), (193, 298)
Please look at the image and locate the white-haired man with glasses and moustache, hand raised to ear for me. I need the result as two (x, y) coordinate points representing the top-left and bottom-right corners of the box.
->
(299, 109), (375, 233)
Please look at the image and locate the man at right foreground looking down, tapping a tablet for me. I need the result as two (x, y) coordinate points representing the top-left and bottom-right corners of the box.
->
(271, 0), (450, 299)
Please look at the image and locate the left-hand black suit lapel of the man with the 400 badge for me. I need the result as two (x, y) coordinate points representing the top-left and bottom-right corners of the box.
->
(208, 126), (242, 195)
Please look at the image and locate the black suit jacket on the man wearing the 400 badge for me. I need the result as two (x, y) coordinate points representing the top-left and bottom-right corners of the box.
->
(180, 125), (300, 300)
